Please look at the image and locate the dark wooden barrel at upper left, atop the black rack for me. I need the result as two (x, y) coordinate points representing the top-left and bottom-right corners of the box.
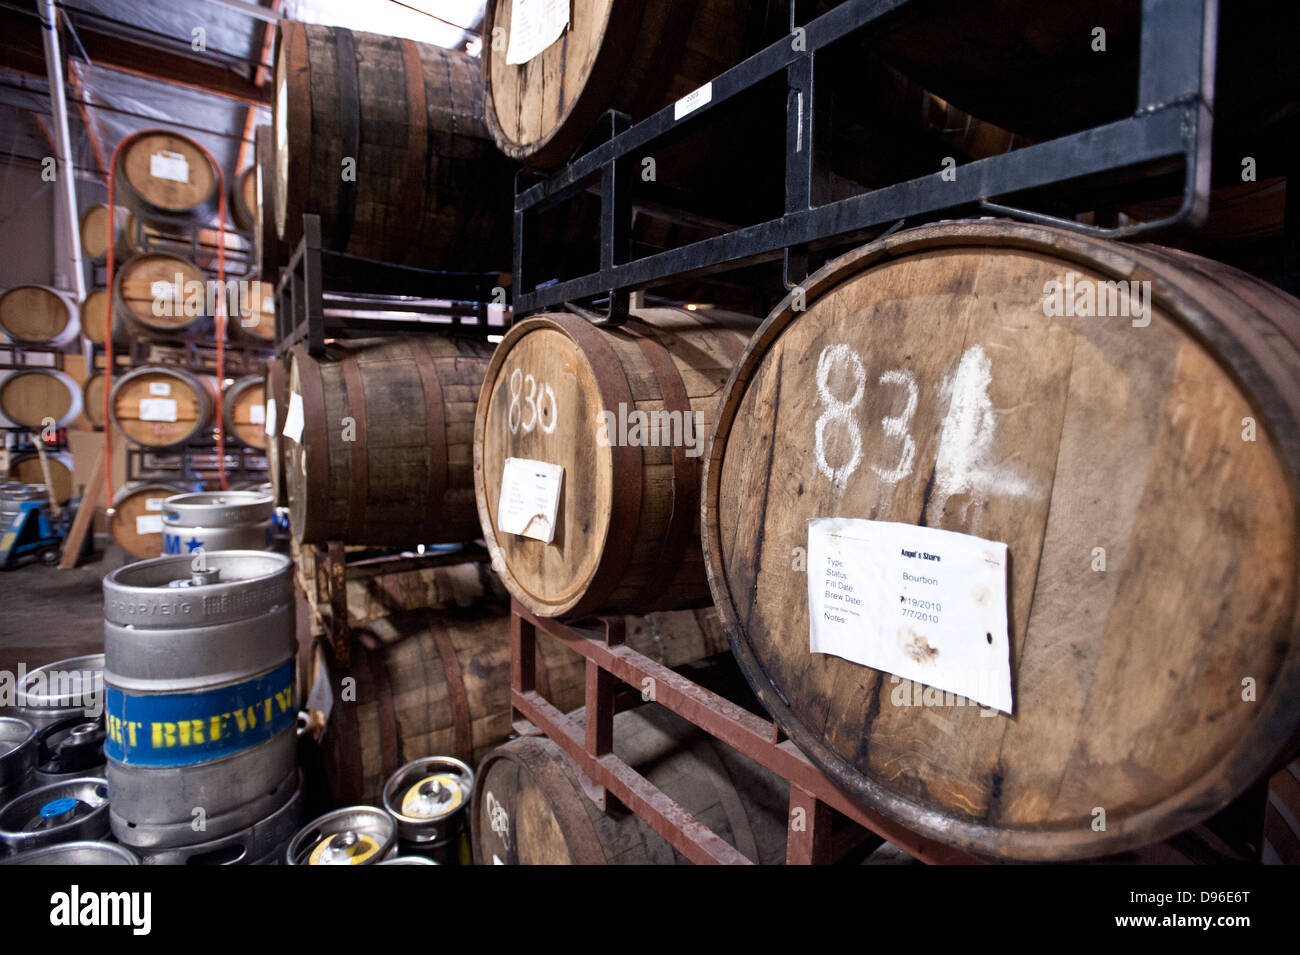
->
(274, 21), (514, 272)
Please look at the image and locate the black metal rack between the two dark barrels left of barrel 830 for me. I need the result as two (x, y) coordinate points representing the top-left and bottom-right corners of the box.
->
(276, 213), (508, 359)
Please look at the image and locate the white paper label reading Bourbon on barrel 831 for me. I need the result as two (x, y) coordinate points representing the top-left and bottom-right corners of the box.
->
(807, 517), (1011, 713)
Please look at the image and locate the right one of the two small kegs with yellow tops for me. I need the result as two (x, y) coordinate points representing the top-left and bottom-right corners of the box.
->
(384, 756), (475, 864)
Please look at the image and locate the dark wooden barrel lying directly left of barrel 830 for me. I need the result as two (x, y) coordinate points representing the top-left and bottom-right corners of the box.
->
(282, 335), (491, 547)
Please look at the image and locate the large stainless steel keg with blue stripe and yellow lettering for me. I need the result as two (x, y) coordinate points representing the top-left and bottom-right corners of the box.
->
(104, 551), (298, 851)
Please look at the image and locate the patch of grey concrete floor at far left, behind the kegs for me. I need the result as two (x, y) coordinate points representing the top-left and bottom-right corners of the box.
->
(0, 541), (133, 673)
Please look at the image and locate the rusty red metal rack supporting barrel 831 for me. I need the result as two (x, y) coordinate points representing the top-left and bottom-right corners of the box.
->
(510, 602), (982, 865)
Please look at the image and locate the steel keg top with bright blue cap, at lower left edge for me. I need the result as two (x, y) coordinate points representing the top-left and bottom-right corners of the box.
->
(0, 776), (108, 852)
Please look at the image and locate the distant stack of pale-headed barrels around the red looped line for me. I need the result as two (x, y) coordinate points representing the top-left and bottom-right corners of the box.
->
(93, 131), (274, 559)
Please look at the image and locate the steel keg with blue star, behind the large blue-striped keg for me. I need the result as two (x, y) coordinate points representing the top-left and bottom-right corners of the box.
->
(163, 491), (276, 555)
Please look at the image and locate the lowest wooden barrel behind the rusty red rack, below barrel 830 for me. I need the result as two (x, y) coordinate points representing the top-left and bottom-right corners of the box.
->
(471, 704), (789, 865)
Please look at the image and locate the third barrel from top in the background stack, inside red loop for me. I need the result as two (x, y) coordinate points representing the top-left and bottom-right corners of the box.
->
(108, 365), (218, 448)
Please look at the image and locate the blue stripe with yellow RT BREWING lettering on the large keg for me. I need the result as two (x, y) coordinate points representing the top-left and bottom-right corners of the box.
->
(104, 659), (298, 767)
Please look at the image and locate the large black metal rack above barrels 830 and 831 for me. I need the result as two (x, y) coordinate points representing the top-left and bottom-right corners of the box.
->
(512, 0), (1217, 324)
